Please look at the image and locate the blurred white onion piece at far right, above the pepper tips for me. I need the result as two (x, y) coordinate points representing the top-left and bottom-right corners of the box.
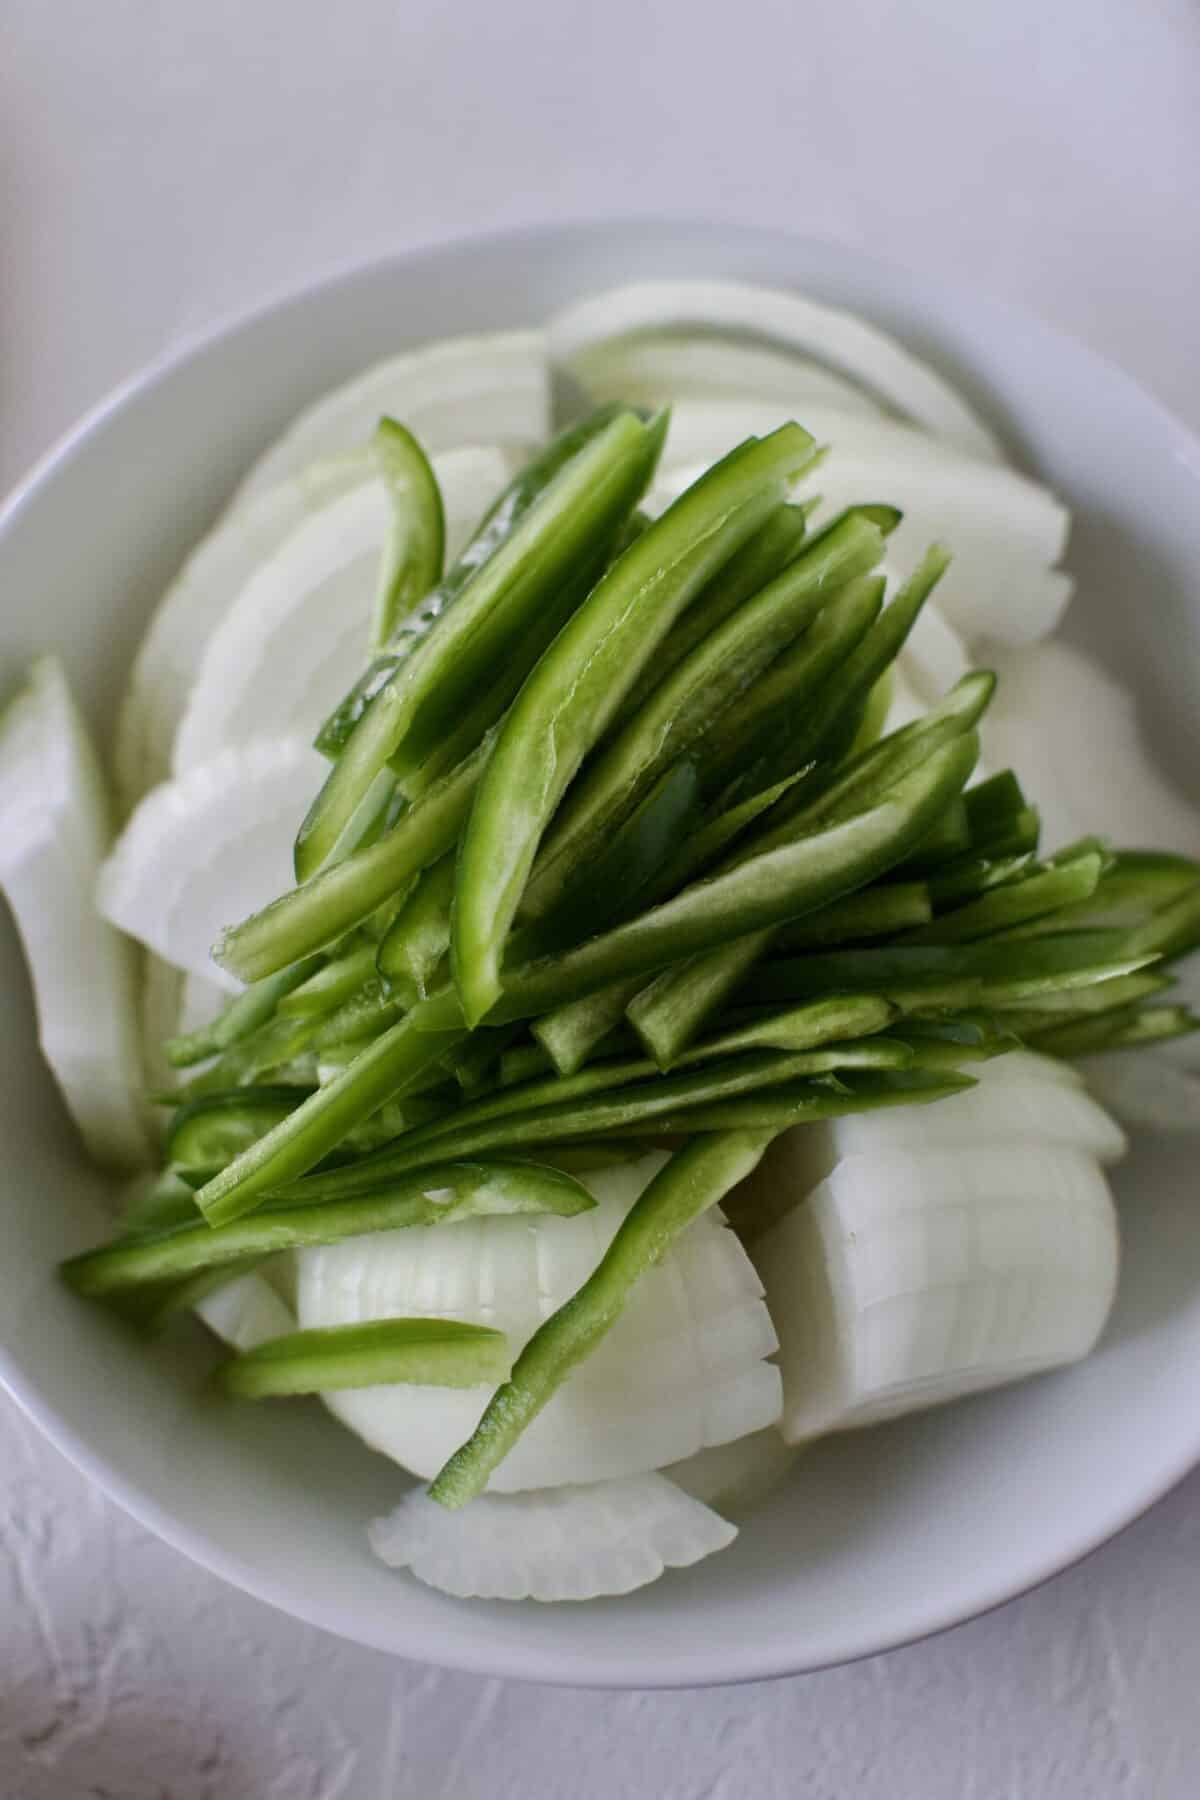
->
(982, 643), (1200, 857)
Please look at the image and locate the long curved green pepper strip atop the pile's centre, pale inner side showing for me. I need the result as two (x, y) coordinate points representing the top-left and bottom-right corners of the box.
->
(453, 414), (811, 1026)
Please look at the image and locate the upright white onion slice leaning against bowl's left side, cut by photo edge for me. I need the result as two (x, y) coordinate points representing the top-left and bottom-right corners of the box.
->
(0, 657), (151, 1168)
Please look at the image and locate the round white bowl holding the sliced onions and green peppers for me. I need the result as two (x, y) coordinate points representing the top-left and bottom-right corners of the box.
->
(0, 223), (1200, 1687)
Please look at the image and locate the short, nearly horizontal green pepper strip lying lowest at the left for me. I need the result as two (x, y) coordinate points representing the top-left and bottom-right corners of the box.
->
(214, 1319), (509, 1400)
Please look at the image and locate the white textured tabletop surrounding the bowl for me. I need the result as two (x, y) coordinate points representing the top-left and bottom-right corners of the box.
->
(0, 0), (1200, 1800)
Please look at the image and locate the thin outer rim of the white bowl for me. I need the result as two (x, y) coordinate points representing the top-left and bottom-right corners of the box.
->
(0, 212), (1200, 1690)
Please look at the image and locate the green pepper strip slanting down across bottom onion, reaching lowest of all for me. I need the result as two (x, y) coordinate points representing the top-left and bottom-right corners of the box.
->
(430, 1132), (770, 1507)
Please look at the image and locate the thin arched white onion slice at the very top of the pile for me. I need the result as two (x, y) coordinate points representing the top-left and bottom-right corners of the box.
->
(547, 281), (1004, 463)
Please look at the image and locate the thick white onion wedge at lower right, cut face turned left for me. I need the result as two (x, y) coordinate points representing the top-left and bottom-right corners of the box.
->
(754, 1144), (1119, 1444)
